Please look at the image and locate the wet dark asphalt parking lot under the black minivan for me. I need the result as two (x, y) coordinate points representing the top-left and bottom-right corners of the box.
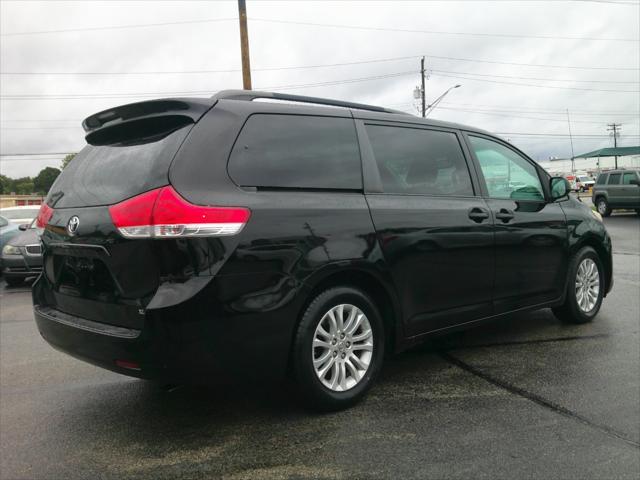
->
(0, 214), (640, 480)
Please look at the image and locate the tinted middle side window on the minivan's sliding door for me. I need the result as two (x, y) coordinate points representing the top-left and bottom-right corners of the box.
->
(366, 125), (473, 196)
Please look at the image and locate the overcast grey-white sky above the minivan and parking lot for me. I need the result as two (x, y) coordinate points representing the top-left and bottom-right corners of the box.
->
(0, 0), (640, 177)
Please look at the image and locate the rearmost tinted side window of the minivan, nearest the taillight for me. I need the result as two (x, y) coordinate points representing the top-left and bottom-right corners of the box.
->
(229, 114), (362, 189)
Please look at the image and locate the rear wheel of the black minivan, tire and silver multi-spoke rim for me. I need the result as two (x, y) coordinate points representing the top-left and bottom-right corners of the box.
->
(292, 287), (385, 411)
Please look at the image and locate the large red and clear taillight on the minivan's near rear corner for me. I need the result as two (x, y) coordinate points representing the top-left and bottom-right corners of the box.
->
(109, 186), (251, 238)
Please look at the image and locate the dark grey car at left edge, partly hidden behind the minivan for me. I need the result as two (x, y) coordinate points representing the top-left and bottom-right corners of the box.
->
(0, 220), (42, 287)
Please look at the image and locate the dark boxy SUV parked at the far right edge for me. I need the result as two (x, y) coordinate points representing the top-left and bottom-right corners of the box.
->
(591, 170), (640, 217)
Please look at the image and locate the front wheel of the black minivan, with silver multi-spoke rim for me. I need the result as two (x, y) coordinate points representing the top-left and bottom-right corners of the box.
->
(553, 247), (605, 324)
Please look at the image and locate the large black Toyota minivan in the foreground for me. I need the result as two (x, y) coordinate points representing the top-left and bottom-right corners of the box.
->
(33, 91), (612, 409)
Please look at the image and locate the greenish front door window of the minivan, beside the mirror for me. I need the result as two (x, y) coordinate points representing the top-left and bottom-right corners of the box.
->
(469, 136), (544, 200)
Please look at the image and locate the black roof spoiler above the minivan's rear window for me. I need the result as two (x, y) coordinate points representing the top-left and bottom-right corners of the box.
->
(82, 98), (216, 145)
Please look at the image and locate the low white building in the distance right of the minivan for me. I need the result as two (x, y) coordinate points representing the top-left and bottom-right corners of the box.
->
(538, 146), (640, 176)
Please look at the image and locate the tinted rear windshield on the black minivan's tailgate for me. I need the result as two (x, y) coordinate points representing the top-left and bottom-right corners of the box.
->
(47, 125), (192, 208)
